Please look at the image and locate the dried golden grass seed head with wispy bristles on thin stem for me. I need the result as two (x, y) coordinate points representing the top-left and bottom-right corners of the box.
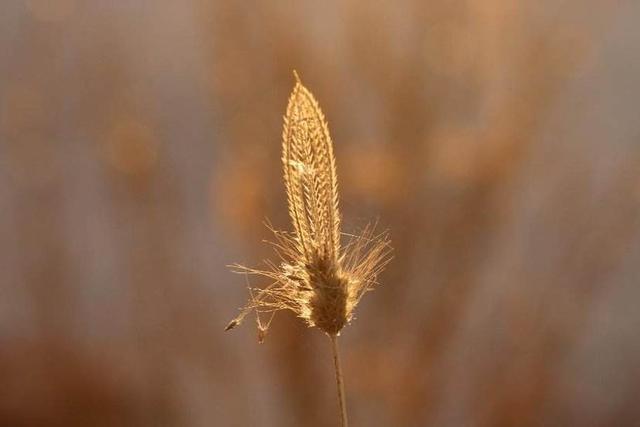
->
(226, 72), (390, 426)
